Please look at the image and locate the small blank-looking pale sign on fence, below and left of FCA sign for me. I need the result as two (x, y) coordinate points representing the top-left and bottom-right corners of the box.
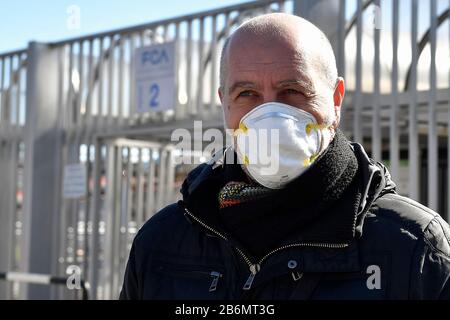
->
(63, 163), (87, 199)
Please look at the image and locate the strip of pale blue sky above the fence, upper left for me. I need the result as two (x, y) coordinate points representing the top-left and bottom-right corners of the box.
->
(0, 0), (248, 53)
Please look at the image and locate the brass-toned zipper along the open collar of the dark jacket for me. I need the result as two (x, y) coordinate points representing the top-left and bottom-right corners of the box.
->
(184, 208), (349, 290)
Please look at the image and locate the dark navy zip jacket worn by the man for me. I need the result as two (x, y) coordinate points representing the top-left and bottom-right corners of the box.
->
(120, 144), (450, 299)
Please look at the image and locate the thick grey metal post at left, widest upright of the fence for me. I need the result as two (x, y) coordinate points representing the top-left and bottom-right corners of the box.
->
(20, 42), (61, 299)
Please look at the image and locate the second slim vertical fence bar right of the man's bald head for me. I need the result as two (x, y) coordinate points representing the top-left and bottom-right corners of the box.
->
(372, 0), (382, 161)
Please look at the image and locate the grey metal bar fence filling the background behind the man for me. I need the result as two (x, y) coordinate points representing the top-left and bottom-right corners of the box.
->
(0, 0), (450, 299)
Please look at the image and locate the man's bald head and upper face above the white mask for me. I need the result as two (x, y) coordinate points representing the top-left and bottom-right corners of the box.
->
(219, 13), (345, 129)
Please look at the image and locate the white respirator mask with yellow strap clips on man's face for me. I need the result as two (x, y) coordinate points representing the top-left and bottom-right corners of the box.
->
(233, 102), (332, 189)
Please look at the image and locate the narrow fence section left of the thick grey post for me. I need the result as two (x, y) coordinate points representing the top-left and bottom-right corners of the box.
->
(0, 51), (27, 297)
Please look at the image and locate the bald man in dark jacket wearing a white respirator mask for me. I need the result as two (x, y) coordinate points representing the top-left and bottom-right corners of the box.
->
(121, 14), (450, 299)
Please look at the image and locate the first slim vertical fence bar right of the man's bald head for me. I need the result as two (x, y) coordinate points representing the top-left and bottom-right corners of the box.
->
(353, 0), (363, 143)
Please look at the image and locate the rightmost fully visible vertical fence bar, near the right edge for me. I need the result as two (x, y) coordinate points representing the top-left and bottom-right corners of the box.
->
(428, 0), (439, 211)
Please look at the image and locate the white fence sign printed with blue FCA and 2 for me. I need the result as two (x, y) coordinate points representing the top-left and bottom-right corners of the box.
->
(134, 42), (177, 113)
